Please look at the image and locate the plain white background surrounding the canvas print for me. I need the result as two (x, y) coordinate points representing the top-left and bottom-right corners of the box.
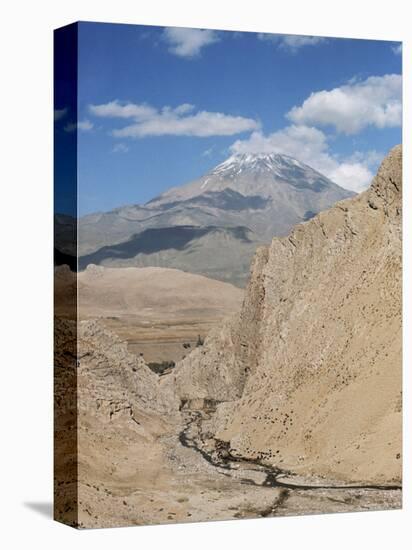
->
(0, 0), (412, 550)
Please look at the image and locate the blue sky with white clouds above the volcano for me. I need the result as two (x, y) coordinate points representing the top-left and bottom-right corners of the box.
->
(55, 23), (402, 215)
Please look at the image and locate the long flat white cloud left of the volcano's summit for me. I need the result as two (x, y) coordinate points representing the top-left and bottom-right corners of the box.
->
(89, 100), (260, 138)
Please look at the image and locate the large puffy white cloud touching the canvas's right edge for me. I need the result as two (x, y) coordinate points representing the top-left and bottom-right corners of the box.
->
(287, 74), (402, 134)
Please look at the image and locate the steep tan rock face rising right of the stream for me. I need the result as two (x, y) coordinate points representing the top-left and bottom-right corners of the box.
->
(175, 146), (402, 483)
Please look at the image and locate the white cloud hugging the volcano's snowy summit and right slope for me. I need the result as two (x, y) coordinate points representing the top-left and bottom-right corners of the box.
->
(231, 125), (382, 193)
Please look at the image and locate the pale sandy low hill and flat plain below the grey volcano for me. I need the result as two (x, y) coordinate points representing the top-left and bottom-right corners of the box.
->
(56, 265), (244, 363)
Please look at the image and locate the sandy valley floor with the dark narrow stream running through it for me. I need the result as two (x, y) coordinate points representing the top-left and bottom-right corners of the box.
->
(75, 390), (402, 528)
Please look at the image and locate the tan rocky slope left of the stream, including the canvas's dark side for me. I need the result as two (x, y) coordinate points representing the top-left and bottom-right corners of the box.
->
(55, 318), (179, 527)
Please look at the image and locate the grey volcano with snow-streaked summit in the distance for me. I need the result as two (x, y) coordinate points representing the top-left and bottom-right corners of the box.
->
(78, 154), (352, 286)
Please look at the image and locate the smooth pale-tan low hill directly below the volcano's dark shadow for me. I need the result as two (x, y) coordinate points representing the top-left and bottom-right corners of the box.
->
(73, 265), (243, 320)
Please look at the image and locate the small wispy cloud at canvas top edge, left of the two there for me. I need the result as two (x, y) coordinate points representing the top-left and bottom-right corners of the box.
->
(163, 27), (219, 58)
